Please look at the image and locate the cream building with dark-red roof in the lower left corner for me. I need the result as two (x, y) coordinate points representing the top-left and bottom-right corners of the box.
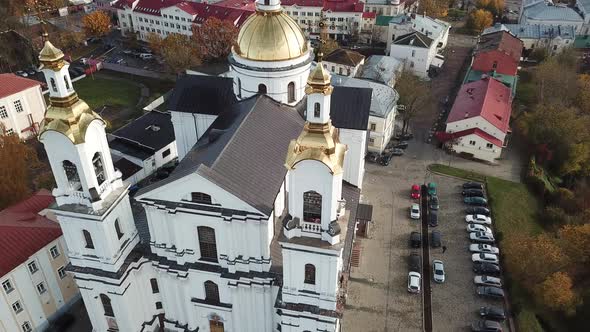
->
(0, 190), (80, 332)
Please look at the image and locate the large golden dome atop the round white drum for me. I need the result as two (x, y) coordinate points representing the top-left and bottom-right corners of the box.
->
(235, 10), (308, 61)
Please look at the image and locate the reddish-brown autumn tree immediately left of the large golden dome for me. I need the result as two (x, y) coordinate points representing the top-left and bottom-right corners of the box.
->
(192, 17), (239, 62)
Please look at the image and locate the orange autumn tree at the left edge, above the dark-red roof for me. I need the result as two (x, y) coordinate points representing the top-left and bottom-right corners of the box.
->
(0, 124), (39, 209)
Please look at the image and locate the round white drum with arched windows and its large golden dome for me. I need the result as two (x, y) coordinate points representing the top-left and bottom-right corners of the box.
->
(229, 0), (314, 105)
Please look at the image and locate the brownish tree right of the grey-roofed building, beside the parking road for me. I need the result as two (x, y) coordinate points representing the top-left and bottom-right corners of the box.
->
(395, 68), (431, 135)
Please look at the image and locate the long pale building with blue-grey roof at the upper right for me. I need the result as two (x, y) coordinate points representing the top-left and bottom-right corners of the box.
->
(482, 23), (576, 54)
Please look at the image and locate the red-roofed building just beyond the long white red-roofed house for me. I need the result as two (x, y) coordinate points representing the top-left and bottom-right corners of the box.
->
(471, 31), (523, 76)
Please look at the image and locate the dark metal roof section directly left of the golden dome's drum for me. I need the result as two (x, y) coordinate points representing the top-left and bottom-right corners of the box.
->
(168, 75), (237, 115)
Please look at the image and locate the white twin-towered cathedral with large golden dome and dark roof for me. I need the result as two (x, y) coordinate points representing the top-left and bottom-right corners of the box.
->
(39, 0), (371, 332)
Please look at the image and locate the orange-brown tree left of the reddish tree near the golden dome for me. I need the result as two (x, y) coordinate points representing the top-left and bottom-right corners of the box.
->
(160, 33), (201, 73)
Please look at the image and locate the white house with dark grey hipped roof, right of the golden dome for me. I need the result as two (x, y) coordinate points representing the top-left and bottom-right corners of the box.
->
(389, 31), (444, 79)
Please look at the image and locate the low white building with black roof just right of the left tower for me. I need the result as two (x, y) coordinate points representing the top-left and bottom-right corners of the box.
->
(109, 111), (178, 184)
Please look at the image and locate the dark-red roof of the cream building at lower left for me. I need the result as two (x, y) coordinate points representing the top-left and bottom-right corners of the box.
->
(0, 190), (62, 276)
